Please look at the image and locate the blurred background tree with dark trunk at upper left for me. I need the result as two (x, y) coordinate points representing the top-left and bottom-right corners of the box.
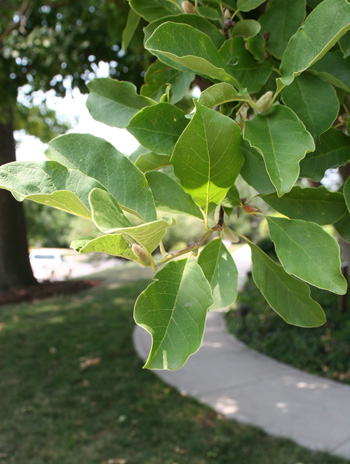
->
(0, 0), (146, 290)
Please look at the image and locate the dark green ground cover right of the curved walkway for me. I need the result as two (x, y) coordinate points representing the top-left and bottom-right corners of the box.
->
(226, 279), (350, 384)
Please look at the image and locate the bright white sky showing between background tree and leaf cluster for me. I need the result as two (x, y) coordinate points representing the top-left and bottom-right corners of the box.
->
(16, 63), (139, 161)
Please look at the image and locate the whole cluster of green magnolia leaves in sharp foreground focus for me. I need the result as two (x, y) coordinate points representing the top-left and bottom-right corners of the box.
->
(0, 0), (350, 369)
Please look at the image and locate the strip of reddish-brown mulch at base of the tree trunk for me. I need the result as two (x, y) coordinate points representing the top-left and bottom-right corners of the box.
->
(0, 279), (101, 306)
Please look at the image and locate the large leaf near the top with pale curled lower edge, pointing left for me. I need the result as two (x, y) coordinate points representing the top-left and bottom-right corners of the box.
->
(146, 21), (239, 87)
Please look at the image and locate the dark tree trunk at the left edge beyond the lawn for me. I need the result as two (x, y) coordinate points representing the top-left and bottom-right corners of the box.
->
(0, 108), (36, 291)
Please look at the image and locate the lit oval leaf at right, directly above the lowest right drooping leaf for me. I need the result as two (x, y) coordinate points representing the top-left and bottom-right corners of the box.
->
(267, 217), (347, 295)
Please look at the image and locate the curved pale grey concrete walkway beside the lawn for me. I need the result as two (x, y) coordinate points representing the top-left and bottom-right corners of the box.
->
(134, 246), (350, 459)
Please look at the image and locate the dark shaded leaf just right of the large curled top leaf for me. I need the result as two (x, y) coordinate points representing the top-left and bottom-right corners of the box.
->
(220, 37), (273, 93)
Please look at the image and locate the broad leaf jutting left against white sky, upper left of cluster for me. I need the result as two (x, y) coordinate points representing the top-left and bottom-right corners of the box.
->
(86, 77), (155, 128)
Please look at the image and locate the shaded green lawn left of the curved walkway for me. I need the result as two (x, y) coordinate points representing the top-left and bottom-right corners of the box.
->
(0, 268), (346, 464)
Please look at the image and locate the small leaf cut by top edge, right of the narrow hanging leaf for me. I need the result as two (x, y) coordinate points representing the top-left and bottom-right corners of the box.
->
(129, 0), (183, 21)
